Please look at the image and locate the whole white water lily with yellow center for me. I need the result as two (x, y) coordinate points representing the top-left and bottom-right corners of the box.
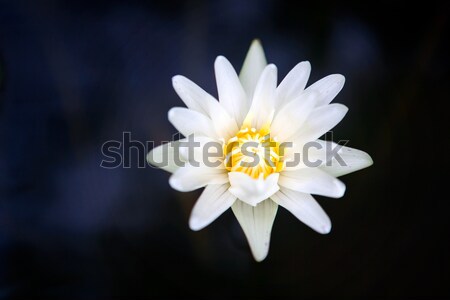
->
(147, 40), (372, 261)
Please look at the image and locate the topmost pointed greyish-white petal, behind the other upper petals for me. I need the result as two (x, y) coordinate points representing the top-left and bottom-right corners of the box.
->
(239, 40), (267, 99)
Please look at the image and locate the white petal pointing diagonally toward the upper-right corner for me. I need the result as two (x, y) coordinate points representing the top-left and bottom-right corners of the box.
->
(305, 74), (345, 106)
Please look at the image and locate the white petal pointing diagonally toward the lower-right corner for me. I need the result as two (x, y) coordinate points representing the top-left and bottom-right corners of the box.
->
(271, 188), (331, 234)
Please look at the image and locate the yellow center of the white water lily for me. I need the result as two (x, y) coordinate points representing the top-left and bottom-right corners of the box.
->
(223, 127), (284, 179)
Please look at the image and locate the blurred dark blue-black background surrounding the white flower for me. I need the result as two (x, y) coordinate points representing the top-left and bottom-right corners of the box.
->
(0, 0), (450, 299)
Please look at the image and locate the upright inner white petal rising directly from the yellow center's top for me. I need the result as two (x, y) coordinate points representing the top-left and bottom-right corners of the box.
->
(244, 64), (277, 129)
